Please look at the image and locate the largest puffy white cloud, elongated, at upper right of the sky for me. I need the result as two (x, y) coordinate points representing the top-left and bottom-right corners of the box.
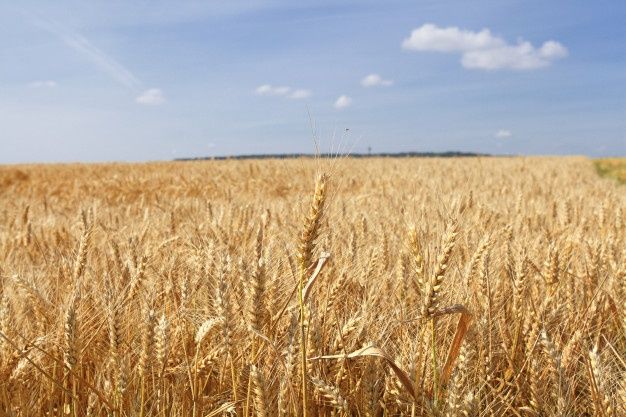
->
(402, 23), (568, 70)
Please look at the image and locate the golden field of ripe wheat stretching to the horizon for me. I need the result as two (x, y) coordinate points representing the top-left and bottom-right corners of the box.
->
(0, 158), (626, 417)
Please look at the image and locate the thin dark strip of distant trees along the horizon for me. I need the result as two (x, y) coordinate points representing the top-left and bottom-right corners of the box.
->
(175, 151), (491, 161)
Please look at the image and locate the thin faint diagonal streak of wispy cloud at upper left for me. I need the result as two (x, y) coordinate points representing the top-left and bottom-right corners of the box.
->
(33, 17), (141, 88)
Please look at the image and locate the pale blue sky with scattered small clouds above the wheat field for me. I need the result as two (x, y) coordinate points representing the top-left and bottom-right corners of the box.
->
(0, 0), (626, 163)
